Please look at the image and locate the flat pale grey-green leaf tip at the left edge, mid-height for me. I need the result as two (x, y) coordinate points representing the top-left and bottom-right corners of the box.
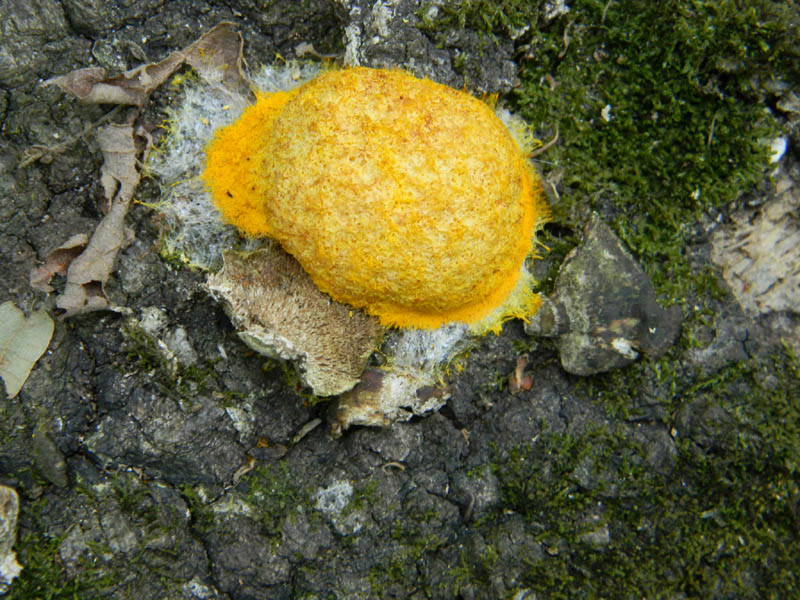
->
(0, 301), (54, 398)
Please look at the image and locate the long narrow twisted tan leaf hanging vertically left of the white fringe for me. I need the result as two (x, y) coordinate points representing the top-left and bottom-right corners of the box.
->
(56, 125), (139, 317)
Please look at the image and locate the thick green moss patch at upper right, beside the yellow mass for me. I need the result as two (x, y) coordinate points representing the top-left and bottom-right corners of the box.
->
(419, 0), (800, 299)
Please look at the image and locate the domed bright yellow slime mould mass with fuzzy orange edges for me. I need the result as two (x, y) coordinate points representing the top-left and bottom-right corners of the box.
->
(203, 68), (546, 329)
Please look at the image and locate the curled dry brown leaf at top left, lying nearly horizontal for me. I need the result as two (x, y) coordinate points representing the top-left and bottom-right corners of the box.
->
(44, 23), (247, 106)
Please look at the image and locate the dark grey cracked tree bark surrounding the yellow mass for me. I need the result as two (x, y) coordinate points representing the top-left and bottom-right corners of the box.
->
(0, 0), (800, 599)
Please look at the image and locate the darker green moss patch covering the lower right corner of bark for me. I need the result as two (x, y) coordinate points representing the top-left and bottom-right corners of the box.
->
(462, 347), (800, 598)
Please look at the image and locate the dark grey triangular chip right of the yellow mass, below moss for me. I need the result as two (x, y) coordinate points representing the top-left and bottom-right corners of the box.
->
(525, 214), (682, 375)
